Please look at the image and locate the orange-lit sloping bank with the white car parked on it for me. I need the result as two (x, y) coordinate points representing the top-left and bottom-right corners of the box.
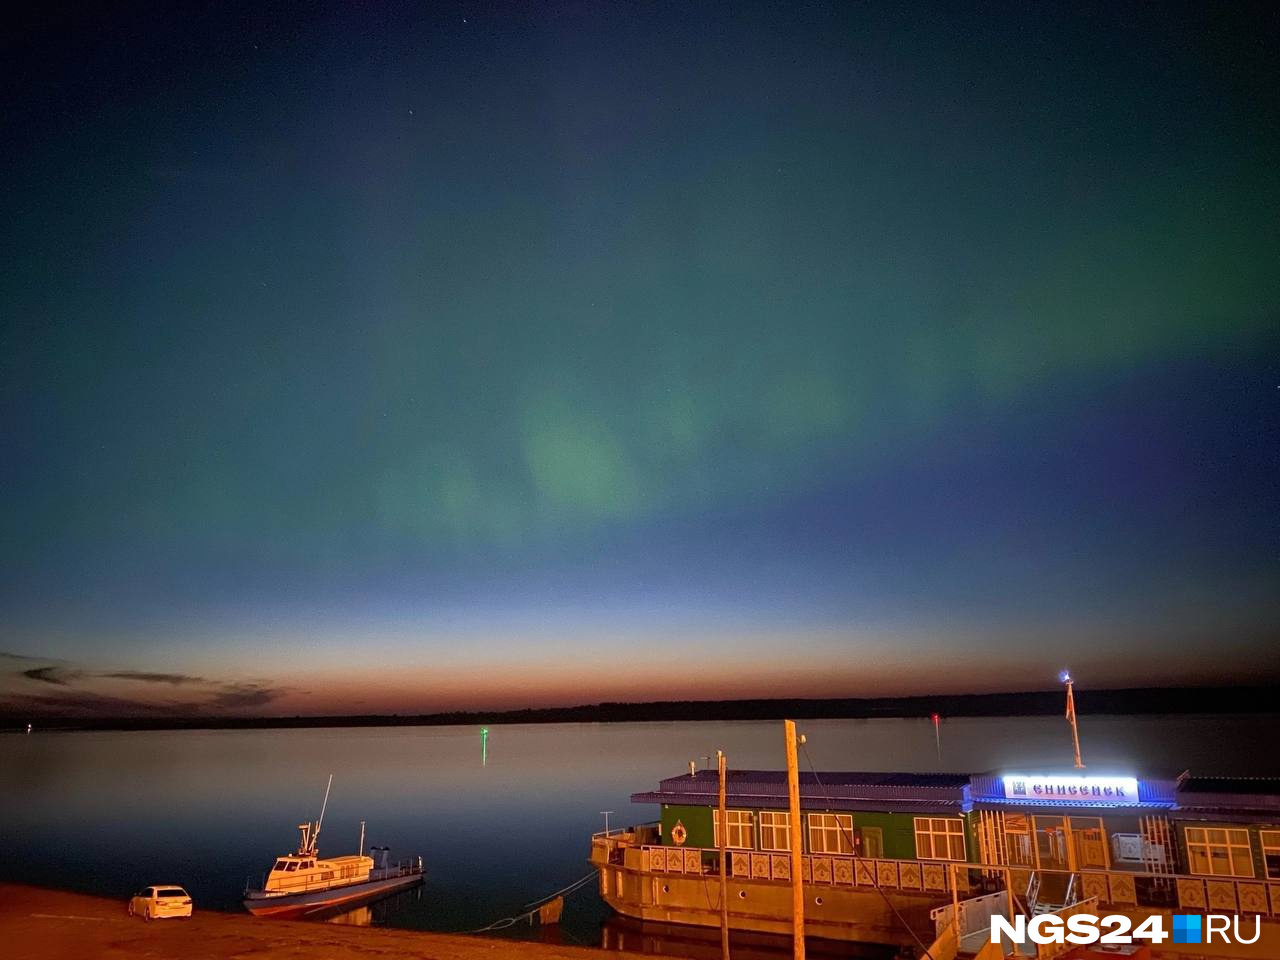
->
(0, 883), (650, 960)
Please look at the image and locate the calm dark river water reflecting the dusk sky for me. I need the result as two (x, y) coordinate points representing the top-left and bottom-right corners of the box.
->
(0, 714), (1280, 952)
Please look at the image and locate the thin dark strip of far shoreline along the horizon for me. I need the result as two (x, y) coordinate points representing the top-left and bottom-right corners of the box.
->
(0, 686), (1280, 732)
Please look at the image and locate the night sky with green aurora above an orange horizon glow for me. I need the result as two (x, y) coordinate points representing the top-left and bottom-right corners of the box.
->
(0, 1), (1280, 714)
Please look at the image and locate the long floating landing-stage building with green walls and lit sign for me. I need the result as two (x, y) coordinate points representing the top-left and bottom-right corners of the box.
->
(591, 769), (1280, 960)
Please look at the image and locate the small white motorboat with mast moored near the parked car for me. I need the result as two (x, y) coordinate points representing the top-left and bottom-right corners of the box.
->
(244, 777), (424, 918)
